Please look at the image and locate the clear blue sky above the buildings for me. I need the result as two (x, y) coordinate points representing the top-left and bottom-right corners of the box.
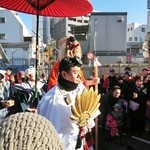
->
(19, 0), (148, 30)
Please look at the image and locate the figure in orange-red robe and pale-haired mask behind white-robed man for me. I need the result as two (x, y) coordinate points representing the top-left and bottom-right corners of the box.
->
(47, 36), (99, 91)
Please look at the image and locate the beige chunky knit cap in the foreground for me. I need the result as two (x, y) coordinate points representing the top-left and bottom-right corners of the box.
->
(0, 112), (63, 150)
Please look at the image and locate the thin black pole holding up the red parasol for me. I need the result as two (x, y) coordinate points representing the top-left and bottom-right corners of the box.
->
(35, 11), (39, 100)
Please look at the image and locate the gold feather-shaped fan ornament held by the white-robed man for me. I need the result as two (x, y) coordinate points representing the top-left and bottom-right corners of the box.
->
(70, 87), (101, 127)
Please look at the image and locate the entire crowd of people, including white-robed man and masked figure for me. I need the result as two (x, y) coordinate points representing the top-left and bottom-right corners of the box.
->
(0, 36), (150, 150)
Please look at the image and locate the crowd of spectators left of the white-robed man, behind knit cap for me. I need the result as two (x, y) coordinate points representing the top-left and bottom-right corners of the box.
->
(0, 67), (47, 120)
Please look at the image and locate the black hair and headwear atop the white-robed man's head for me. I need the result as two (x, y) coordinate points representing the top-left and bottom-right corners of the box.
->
(59, 56), (83, 72)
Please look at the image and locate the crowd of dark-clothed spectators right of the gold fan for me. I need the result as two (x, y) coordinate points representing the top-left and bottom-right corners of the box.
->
(100, 67), (150, 136)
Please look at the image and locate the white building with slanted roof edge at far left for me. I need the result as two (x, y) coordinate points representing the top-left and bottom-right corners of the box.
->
(0, 8), (32, 66)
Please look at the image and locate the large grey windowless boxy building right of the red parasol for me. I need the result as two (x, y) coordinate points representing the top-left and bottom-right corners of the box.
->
(89, 12), (127, 64)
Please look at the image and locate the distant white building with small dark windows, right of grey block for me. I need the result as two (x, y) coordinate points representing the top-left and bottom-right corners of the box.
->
(127, 22), (147, 64)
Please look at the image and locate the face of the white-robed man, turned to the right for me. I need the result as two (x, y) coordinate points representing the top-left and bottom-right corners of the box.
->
(62, 66), (81, 84)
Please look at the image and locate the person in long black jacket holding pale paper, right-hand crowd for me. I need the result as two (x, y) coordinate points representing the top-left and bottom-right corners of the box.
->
(129, 76), (147, 136)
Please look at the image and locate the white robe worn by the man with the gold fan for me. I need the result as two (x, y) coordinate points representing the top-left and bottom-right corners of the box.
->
(37, 84), (99, 150)
